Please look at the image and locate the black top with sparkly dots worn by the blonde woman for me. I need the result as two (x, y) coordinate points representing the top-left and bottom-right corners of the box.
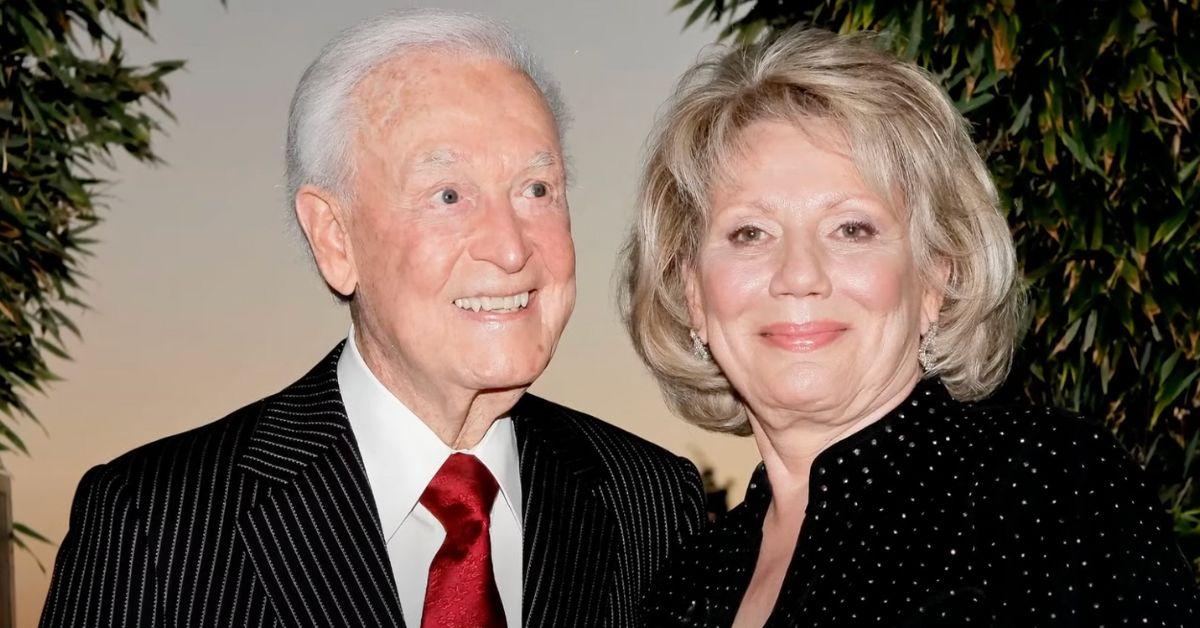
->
(646, 382), (1200, 628)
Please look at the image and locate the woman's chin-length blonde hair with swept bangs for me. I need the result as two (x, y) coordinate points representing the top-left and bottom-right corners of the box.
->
(620, 29), (1025, 435)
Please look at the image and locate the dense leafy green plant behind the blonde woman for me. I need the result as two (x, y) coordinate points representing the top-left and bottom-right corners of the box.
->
(676, 0), (1200, 581)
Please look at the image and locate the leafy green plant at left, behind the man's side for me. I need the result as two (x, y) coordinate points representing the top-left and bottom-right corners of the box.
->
(0, 0), (182, 559)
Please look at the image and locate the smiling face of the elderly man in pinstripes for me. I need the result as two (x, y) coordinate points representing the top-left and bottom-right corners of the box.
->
(347, 50), (575, 403)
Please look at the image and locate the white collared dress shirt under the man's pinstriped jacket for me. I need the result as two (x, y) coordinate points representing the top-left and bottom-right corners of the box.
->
(337, 329), (523, 628)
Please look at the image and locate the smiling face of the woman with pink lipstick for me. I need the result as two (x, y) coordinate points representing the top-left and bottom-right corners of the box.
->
(688, 120), (940, 423)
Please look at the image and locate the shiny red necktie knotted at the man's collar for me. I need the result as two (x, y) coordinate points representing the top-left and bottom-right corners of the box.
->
(421, 454), (505, 628)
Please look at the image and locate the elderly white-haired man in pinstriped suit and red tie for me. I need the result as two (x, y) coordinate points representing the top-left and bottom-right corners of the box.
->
(42, 11), (703, 627)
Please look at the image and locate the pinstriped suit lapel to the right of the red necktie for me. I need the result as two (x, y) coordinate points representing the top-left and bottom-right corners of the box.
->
(511, 395), (618, 627)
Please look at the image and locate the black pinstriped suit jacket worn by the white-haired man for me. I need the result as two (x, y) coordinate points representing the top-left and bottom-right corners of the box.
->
(42, 346), (704, 627)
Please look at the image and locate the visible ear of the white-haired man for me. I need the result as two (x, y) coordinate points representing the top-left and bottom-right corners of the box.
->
(295, 185), (359, 297)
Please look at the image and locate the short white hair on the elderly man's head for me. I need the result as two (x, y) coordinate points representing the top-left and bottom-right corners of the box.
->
(287, 8), (568, 207)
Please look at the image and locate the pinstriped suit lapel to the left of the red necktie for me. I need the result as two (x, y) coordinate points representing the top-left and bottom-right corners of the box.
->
(238, 345), (403, 626)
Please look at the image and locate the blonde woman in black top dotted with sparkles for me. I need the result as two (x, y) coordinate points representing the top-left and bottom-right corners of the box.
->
(623, 30), (1200, 627)
